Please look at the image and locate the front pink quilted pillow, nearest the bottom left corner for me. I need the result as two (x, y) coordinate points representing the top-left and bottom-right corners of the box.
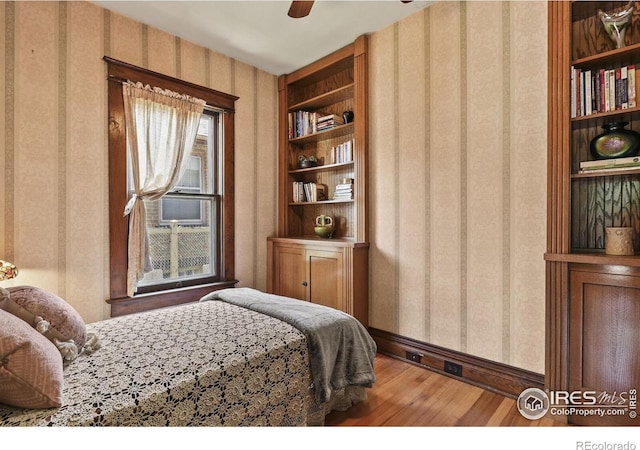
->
(0, 310), (64, 408)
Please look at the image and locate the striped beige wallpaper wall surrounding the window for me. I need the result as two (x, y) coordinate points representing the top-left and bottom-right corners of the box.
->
(0, 1), (277, 322)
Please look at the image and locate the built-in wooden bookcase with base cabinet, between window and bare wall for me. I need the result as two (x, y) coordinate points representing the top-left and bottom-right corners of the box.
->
(267, 36), (369, 326)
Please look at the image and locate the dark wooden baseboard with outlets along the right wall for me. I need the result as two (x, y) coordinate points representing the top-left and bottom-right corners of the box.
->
(369, 328), (544, 398)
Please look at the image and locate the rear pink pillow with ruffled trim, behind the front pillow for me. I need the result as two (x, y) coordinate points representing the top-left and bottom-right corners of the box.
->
(0, 286), (87, 361)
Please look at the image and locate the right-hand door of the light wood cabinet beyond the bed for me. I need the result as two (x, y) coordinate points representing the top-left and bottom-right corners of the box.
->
(306, 250), (344, 310)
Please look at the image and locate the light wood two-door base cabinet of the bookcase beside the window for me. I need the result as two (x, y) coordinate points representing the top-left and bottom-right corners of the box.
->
(267, 238), (368, 326)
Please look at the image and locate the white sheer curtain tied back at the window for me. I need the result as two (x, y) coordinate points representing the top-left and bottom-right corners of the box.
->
(122, 81), (206, 296)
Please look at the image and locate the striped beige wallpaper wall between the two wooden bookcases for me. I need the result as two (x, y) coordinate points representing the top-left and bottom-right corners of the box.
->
(369, 2), (547, 373)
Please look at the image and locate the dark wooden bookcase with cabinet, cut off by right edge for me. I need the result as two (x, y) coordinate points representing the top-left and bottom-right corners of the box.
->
(545, 1), (640, 425)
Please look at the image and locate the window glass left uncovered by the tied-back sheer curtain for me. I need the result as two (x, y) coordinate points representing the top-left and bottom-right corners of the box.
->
(136, 108), (222, 293)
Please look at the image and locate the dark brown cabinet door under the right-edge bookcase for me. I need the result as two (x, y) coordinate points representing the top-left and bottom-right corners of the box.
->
(569, 270), (640, 425)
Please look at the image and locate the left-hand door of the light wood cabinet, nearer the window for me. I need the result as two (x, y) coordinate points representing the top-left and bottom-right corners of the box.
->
(273, 245), (307, 300)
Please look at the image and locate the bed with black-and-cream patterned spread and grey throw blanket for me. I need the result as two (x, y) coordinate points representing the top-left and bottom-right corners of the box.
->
(0, 288), (376, 426)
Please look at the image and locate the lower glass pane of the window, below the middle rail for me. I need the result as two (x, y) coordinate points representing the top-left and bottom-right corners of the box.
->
(139, 198), (218, 286)
